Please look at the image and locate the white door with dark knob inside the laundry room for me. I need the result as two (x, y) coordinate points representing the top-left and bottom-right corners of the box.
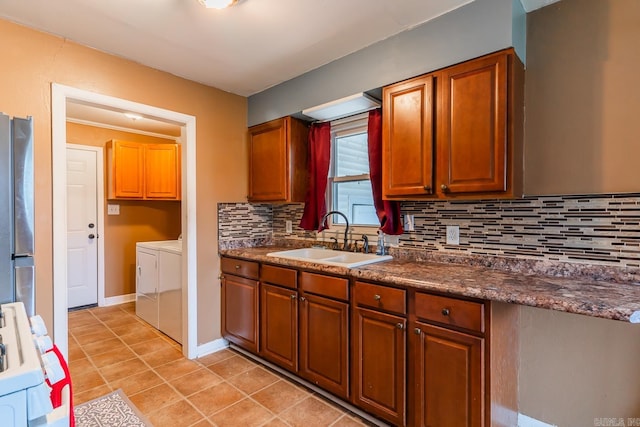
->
(67, 147), (99, 308)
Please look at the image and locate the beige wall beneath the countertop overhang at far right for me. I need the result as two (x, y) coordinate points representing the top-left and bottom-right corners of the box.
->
(519, 307), (640, 427)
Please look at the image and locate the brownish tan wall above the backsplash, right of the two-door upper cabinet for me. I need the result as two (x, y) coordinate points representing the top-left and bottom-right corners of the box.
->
(525, 0), (640, 195)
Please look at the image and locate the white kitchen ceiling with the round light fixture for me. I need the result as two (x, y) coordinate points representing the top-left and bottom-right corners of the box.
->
(0, 0), (557, 134)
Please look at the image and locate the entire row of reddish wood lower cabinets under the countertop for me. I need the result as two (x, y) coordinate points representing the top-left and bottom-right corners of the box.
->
(222, 257), (492, 427)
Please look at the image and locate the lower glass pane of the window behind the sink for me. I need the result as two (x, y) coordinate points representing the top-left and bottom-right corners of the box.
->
(332, 180), (380, 226)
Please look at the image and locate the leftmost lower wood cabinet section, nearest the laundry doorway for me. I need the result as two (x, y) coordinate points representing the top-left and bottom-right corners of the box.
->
(221, 258), (260, 353)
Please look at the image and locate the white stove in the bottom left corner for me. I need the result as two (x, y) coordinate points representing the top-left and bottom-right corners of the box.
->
(0, 302), (69, 427)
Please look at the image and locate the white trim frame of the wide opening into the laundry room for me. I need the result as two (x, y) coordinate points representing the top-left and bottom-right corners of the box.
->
(51, 83), (198, 359)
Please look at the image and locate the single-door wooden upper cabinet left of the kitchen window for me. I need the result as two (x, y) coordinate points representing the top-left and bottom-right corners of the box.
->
(248, 117), (309, 203)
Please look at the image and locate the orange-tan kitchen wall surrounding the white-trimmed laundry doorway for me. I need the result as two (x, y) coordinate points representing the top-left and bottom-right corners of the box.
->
(0, 20), (247, 343)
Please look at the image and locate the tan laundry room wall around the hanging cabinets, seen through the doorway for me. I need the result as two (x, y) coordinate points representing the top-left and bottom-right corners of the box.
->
(67, 123), (181, 297)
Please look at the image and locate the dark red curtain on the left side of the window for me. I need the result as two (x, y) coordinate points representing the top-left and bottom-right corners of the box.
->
(300, 122), (331, 231)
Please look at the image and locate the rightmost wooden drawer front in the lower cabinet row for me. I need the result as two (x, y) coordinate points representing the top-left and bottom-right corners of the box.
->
(416, 292), (484, 333)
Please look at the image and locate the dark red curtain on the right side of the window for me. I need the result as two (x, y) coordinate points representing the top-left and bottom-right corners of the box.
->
(368, 109), (403, 235)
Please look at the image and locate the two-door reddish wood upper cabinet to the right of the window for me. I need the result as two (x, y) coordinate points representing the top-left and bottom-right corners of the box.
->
(383, 49), (524, 199)
